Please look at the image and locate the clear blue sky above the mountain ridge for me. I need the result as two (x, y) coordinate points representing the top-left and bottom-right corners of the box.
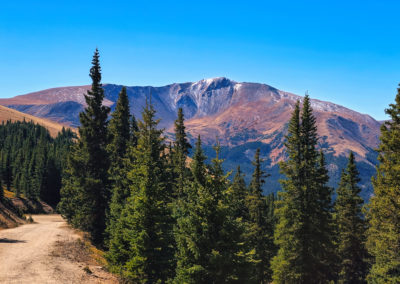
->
(0, 0), (400, 119)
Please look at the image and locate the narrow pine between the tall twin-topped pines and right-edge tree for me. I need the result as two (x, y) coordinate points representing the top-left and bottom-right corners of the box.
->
(335, 152), (367, 283)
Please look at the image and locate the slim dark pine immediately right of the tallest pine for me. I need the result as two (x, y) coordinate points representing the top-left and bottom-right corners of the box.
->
(107, 87), (132, 244)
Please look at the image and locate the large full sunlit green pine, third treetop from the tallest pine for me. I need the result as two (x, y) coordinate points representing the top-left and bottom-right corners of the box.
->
(107, 98), (173, 283)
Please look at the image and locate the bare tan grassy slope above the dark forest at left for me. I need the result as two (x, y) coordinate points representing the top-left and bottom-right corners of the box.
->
(0, 105), (75, 137)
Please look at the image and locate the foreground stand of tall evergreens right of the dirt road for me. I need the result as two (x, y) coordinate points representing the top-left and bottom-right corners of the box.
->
(58, 50), (400, 283)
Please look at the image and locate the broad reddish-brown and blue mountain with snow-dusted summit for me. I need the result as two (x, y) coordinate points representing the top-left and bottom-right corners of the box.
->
(0, 77), (381, 198)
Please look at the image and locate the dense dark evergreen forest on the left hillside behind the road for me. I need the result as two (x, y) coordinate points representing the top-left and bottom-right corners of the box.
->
(0, 121), (75, 205)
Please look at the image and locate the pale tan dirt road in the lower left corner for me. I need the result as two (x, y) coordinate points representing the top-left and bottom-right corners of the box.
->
(0, 215), (116, 284)
